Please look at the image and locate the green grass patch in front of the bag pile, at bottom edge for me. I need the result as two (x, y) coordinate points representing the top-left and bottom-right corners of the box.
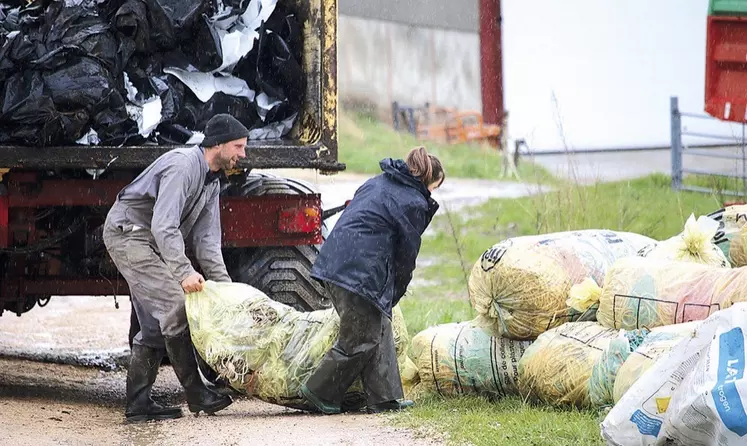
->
(391, 397), (604, 446)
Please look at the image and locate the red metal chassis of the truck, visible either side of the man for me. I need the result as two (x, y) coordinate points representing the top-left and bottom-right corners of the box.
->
(0, 172), (322, 300)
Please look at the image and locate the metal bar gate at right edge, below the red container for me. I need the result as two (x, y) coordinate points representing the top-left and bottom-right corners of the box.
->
(670, 96), (747, 197)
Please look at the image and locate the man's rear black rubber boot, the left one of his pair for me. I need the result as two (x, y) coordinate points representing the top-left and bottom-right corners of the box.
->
(125, 344), (183, 423)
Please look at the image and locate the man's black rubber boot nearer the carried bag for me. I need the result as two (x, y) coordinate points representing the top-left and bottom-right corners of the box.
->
(164, 331), (233, 415)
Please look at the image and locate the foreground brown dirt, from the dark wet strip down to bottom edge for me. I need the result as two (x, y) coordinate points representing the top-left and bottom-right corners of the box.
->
(0, 358), (437, 446)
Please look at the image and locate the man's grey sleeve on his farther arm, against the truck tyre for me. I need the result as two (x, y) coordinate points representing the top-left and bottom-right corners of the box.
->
(191, 187), (231, 282)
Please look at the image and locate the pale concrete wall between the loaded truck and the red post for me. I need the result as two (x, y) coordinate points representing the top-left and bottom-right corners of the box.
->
(338, 15), (481, 112)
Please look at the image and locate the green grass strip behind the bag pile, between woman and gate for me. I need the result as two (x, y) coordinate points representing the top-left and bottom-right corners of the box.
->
(416, 175), (722, 299)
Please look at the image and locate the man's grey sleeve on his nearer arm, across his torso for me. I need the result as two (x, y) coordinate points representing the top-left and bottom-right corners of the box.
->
(151, 156), (196, 283)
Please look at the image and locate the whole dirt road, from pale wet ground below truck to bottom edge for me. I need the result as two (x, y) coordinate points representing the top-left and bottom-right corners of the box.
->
(0, 297), (440, 446)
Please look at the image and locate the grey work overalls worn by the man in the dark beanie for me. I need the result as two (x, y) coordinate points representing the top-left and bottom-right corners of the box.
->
(104, 147), (231, 349)
